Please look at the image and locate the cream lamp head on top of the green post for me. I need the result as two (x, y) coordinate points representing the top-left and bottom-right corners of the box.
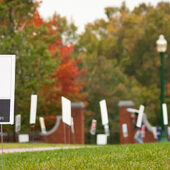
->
(156, 34), (167, 53)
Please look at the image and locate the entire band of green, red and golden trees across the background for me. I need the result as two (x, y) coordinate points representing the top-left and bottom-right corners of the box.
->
(0, 0), (170, 143)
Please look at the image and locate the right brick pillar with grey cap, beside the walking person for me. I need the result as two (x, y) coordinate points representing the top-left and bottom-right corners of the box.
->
(118, 101), (135, 144)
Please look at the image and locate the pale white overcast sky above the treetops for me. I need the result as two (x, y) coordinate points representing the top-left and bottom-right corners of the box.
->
(39, 0), (170, 33)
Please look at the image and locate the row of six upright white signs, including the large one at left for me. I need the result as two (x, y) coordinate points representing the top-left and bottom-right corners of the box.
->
(0, 55), (168, 127)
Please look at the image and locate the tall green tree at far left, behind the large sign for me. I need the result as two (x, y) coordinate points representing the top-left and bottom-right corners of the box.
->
(0, 0), (57, 129)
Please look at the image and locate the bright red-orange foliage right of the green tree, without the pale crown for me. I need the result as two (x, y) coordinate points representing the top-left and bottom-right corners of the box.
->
(33, 11), (87, 115)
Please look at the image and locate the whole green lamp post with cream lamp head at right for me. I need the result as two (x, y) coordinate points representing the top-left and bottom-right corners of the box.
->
(156, 34), (167, 141)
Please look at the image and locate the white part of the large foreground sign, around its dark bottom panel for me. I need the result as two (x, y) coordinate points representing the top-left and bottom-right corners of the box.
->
(0, 55), (15, 124)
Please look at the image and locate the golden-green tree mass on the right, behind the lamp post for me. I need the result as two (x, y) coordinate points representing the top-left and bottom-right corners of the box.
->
(76, 2), (170, 143)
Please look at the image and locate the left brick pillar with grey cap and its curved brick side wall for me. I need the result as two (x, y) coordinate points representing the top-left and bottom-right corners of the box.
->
(40, 102), (84, 144)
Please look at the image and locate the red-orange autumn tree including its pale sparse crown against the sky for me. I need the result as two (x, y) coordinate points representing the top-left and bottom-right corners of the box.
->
(38, 14), (86, 115)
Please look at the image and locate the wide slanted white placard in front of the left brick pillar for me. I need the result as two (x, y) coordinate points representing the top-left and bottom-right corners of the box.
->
(61, 96), (71, 126)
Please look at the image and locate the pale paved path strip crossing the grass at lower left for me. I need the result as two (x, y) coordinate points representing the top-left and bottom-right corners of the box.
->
(3, 146), (93, 153)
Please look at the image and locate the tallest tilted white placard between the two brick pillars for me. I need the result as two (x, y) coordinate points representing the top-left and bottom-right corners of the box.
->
(100, 100), (108, 125)
